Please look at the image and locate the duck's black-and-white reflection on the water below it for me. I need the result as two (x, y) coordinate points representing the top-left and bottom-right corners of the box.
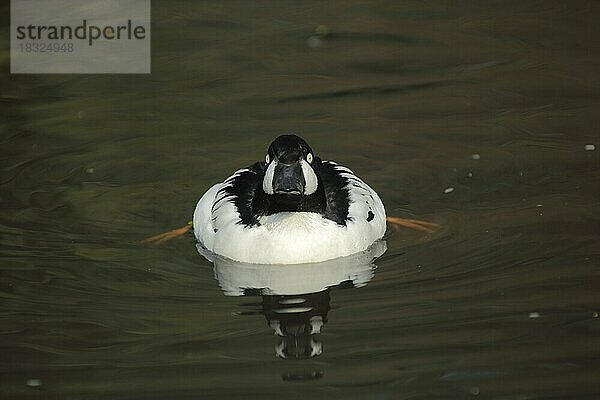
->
(198, 241), (386, 358)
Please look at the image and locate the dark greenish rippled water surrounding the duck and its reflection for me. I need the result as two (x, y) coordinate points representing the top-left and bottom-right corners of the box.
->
(0, 1), (600, 400)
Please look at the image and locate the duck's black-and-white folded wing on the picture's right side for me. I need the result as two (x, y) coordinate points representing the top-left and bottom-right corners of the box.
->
(320, 161), (385, 230)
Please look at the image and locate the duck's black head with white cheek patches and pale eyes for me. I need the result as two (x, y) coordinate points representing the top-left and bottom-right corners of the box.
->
(263, 135), (319, 196)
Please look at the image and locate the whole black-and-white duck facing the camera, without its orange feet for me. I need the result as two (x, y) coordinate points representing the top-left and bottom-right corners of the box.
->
(194, 135), (386, 264)
